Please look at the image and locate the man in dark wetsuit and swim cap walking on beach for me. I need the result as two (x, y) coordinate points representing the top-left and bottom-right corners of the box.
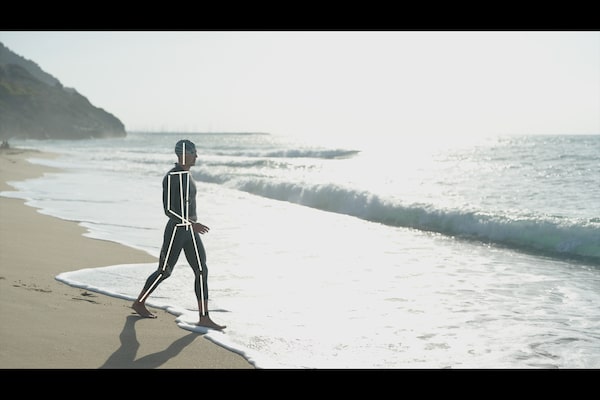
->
(132, 140), (225, 330)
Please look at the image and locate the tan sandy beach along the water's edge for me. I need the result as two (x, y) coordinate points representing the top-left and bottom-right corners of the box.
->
(0, 148), (254, 369)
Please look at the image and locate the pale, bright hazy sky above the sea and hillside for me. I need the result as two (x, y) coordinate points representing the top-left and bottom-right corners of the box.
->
(0, 31), (600, 144)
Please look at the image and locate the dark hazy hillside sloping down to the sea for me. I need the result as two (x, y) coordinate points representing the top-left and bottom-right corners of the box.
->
(0, 43), (126, 141)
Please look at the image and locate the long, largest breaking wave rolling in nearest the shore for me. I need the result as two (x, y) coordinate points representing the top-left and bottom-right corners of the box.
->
(213, 179), (600, 265)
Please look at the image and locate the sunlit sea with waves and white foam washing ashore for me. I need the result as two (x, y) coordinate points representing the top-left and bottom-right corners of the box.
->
(0, 132), (600, 369)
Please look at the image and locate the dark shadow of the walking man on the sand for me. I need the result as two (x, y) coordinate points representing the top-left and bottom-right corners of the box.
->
(100, 315), (198, 368)
